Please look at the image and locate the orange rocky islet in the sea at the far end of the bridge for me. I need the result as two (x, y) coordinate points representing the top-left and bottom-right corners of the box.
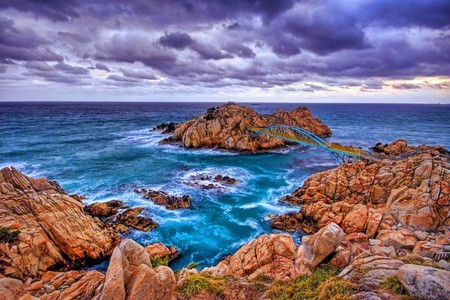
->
(165, 104), (331, 151)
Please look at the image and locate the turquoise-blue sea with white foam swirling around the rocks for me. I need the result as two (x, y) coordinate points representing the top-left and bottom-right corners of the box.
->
(0, 103), (450, 269)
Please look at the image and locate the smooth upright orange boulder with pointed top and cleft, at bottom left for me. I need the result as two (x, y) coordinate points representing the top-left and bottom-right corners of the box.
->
(99, 240), (176, 300)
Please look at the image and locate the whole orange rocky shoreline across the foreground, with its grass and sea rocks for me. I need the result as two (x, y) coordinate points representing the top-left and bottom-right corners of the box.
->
(0, 135), (450, 299)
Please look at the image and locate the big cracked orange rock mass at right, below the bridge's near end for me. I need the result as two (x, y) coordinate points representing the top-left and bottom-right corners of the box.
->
(284, 142), (450, 236)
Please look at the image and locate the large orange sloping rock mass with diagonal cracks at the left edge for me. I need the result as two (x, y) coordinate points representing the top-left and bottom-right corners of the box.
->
(0, 168), (120, 278)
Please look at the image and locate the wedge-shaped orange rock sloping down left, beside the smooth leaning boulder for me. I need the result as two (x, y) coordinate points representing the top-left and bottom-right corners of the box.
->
(203, 234), (296, 279)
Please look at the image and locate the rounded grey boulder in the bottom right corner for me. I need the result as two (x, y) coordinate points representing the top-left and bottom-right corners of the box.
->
(397, 264), (450, 300)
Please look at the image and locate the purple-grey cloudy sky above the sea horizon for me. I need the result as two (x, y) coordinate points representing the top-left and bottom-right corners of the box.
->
(0, 0), (450, 104)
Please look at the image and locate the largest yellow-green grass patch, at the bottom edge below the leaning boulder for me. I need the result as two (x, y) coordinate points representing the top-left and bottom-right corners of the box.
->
(266, 265), (356, 300)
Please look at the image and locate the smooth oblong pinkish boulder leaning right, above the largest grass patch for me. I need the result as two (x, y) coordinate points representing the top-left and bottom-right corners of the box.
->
(295, 223), (345, 276)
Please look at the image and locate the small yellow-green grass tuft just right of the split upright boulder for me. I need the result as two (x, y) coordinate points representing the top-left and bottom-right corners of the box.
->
(182, 274), (225, 296)
